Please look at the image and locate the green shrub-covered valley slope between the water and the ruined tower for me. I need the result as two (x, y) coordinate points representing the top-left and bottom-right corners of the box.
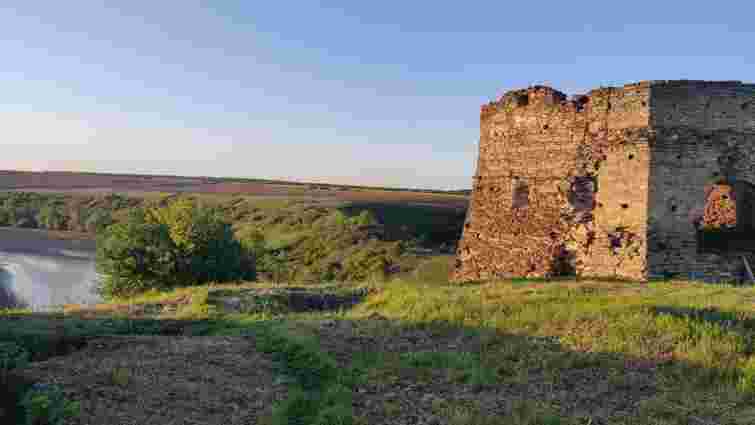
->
(0, 193), (464, 288)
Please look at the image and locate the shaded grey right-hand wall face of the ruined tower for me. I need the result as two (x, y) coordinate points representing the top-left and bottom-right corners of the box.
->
(648, 81), (755, 278)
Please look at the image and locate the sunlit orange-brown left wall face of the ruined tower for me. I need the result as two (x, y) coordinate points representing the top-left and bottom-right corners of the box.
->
(453, 84), (649, 281)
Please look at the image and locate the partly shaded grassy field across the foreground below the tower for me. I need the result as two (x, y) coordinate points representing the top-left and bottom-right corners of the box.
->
(0, 279), (755, 425)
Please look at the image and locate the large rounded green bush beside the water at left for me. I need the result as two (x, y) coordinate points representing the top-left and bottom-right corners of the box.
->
(97, 200), (255, 297)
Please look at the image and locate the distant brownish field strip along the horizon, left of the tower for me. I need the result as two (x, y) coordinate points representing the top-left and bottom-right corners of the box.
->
(0, 171), (468, 208)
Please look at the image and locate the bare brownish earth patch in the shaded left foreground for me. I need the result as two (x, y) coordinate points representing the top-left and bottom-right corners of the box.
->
(24, 336), (285, 425)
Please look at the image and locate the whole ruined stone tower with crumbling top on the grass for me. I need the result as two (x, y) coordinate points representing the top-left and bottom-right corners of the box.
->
(453, 81), (755, 281)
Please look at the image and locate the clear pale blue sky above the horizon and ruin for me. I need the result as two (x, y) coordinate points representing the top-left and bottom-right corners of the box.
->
(0, 0), (755, 189)
